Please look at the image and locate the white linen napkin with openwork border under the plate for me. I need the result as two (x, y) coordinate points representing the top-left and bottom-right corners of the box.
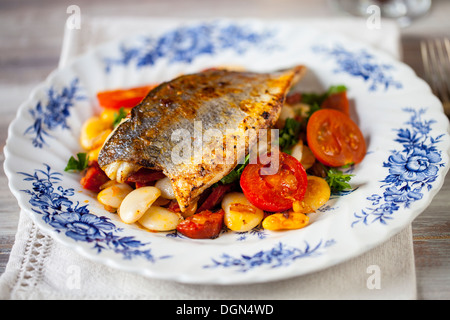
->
(0, 17), (416, 300)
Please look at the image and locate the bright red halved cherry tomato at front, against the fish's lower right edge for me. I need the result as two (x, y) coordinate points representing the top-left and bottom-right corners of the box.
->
(240, 152), (307, 212)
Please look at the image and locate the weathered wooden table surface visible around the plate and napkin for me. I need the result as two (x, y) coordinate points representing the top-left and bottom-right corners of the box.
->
(0, 0), (450, 300)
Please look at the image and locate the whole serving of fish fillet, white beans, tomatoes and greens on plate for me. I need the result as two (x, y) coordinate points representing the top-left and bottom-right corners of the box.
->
(65, 66), (366, 239)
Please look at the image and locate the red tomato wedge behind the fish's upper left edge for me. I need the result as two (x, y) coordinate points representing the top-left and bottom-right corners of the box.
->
(97, 84), (156, 110)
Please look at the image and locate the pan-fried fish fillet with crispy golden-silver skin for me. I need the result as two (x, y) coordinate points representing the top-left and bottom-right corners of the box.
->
(98, 66), (306, 211)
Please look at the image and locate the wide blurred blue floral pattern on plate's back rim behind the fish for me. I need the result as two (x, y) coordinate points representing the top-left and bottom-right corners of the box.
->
(104, 22), (277, 72)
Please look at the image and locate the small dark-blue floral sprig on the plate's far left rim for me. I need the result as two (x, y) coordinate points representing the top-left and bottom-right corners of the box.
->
(24, 79), (86, 148)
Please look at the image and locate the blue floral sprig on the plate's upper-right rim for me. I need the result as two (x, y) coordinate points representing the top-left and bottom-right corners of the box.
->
(312, 44), (403, 91)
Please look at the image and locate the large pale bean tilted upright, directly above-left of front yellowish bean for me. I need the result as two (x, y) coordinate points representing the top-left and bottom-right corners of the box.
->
(118, 186), (161, 223)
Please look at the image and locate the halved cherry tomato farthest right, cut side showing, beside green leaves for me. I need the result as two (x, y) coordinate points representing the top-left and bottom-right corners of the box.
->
(306, 109), (366, 167)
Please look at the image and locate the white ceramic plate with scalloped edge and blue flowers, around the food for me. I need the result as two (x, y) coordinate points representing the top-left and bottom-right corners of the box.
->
(5, 20), (450, 284)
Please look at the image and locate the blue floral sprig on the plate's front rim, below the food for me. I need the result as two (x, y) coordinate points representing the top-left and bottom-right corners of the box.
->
(203, 239), (336, 272)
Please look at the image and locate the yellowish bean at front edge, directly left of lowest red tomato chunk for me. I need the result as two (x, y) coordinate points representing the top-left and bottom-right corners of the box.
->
(138, 206), (183, 231)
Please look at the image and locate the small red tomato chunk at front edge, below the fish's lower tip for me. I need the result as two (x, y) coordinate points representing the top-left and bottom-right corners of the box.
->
(177, 210), (225, 239)
